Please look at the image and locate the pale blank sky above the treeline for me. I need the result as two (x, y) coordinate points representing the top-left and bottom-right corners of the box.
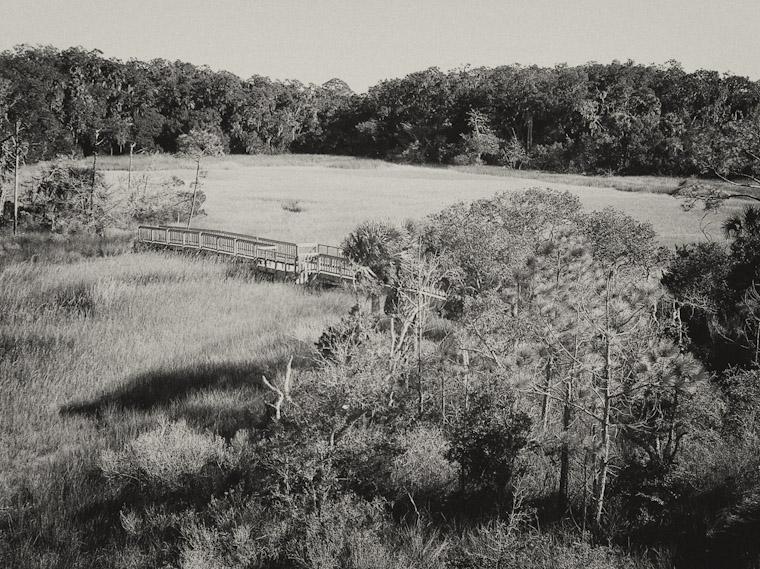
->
(0, 0), (760, 92)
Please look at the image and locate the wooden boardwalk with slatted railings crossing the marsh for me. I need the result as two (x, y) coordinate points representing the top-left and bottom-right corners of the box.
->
(137, 225), (446, 300)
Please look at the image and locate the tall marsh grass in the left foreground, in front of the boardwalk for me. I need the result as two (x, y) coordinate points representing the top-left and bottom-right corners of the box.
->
(0, 247), (352, 567)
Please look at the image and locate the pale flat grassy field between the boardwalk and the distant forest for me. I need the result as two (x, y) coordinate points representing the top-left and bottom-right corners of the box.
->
(27, 155), (743, 246)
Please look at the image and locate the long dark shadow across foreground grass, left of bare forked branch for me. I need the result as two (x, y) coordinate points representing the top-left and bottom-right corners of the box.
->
(60, 357), (314, 436)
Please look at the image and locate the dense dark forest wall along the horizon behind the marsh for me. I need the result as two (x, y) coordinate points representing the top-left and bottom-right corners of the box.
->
(0, 46), (760, 176)
